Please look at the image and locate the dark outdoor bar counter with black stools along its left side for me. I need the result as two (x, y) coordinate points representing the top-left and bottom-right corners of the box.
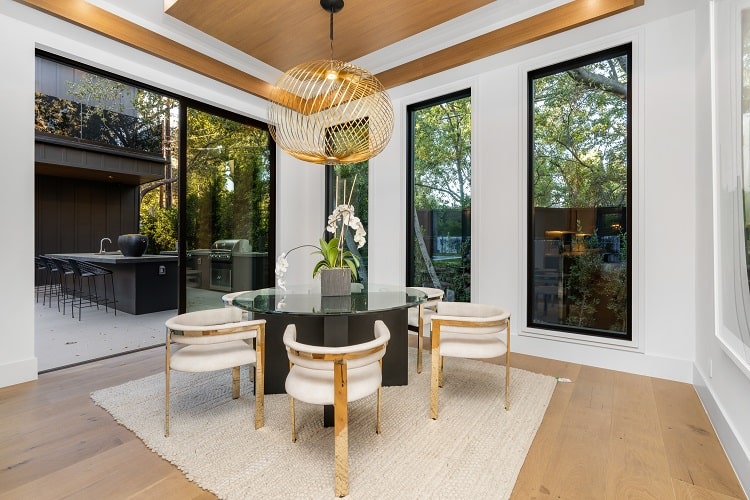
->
(52, 252), (177, 314)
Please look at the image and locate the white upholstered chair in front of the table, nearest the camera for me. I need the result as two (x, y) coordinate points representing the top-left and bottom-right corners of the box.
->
(284, 320), (391, 497)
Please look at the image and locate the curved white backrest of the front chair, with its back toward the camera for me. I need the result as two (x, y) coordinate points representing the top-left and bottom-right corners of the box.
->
(284, 320), (391, 371)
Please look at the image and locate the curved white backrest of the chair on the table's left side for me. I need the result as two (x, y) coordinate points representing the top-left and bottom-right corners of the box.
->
(165, 307), (265, 344)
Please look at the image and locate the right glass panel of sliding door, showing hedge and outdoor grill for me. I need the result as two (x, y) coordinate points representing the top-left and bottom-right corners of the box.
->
(185, 108), (273, 310)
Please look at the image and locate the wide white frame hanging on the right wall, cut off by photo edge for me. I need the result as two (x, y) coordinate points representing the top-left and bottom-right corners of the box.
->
(711, 0), (750, 377)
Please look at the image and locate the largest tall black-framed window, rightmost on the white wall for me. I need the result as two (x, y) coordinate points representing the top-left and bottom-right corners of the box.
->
(528, 46), (630, 338)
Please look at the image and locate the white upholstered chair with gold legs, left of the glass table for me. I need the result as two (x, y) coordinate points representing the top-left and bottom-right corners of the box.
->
(164, 307), (266, 436)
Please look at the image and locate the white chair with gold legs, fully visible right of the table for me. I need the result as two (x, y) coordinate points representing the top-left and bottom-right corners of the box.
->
(430, 302), (510, 419)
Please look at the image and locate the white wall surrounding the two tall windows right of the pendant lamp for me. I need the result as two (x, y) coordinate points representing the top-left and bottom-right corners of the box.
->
(376, 1), (696, 382)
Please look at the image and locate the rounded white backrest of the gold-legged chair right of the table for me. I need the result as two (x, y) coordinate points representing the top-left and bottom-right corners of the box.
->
(432, 302), (510, 334)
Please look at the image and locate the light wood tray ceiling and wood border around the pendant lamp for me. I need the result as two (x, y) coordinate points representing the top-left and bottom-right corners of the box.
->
(16, 0), (645, 99)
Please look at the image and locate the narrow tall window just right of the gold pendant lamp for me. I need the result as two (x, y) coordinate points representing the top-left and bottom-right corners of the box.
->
(407, 92), (471, 302)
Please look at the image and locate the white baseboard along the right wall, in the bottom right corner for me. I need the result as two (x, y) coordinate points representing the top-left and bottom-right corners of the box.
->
(693, 366), (750, 495)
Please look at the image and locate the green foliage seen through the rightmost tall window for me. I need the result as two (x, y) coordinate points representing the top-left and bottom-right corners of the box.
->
(530, 48), (629, 333)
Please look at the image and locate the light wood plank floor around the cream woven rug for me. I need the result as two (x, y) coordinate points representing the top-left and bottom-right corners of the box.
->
(0, 336), (745, 500)
